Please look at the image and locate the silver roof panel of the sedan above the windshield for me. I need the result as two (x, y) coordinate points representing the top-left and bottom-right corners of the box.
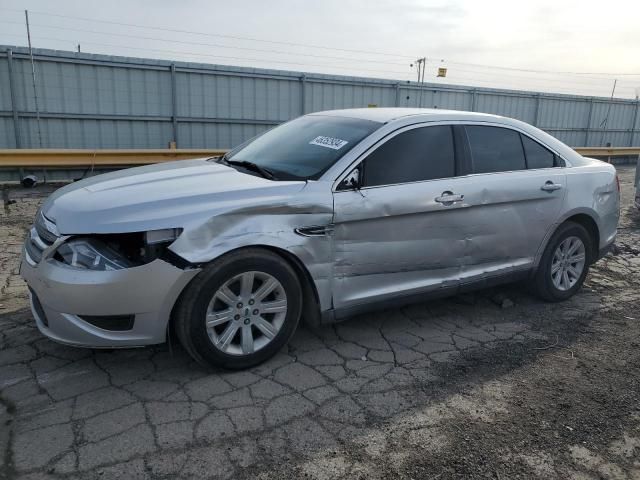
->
(310, 107), (510, 123)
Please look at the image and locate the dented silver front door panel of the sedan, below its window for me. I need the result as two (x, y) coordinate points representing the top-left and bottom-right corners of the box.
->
(333, 178), (468, 309)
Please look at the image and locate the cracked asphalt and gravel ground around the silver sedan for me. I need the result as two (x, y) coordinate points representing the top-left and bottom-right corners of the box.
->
(0, 167), (640, 480)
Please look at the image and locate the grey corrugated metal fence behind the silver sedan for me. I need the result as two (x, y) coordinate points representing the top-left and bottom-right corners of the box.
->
(0, 46), (640, 148)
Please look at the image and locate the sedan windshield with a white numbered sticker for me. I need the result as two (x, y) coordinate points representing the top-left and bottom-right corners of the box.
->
(225, 115), (382, 180)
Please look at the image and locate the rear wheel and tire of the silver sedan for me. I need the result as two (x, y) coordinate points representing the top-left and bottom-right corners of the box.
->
(533, 222), (593, 302)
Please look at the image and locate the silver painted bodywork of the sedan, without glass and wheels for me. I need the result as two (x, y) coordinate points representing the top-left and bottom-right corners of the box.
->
(22, 108), (619, 346)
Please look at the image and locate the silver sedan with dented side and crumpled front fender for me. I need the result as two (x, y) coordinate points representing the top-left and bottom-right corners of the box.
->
(21, 108), (620, 368)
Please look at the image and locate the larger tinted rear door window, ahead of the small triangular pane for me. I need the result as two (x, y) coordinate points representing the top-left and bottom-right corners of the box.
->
(465, 125), (527, 173)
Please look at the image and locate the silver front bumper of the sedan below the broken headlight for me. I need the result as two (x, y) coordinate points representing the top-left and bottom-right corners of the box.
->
(20, 249), (200, 348)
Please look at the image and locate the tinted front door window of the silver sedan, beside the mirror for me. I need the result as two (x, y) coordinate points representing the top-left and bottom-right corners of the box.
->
(364, 125), (455, 187)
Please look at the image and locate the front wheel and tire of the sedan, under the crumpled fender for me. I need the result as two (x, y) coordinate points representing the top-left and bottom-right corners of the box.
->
(174, 248), (302, 370)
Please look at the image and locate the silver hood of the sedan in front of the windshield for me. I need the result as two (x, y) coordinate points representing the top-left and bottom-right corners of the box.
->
(42, 159), (306, 235)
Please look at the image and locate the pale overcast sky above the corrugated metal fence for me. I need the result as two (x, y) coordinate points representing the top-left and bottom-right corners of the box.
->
(0, 0), (640, 97)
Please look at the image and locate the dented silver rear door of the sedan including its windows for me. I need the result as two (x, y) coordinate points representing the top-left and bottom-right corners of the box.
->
(462, 123), (566, 283)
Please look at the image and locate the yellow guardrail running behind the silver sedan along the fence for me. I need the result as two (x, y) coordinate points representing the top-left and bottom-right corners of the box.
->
(0, 147), (640, 168)
